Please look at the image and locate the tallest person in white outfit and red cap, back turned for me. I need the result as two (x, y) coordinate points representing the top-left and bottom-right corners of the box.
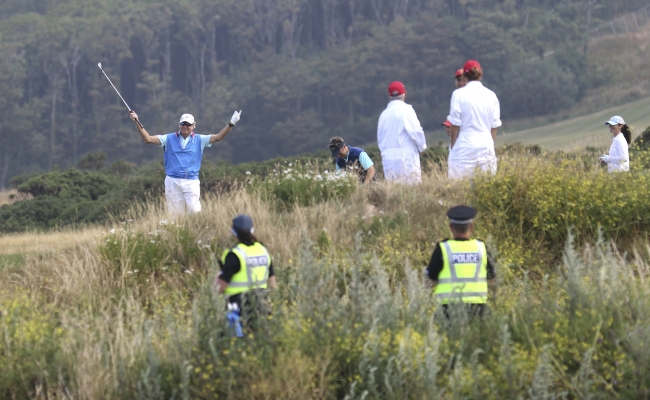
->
(447, 60), (501, 179)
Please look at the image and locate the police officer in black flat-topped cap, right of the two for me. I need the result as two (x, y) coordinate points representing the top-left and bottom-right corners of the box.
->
(426, 206), (495, 317)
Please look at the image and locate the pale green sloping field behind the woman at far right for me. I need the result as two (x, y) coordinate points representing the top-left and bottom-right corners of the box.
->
(497, 97), (650, 151)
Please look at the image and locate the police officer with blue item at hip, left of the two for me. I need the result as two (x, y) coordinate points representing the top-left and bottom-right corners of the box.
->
(215, 214), (276, 336)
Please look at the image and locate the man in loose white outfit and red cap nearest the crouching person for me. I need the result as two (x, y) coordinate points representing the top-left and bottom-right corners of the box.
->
(377, 81), (427, 184)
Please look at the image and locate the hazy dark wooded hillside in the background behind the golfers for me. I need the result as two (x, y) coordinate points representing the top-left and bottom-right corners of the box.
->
(0, 0), (645, 188)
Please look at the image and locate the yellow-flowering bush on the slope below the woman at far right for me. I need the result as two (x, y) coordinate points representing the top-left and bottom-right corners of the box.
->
(471, 154), (650, 269)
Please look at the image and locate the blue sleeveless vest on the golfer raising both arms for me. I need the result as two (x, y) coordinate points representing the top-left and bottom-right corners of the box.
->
(165, 133), (203, 179)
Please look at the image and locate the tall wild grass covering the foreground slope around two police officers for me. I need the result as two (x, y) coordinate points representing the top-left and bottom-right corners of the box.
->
(0, 155), (650, 399)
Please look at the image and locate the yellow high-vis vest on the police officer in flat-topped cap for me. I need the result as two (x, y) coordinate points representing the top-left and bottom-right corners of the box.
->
(434, 239), (488, 304)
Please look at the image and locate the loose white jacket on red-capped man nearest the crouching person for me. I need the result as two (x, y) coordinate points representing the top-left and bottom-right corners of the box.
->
(377, 100), (427, 157)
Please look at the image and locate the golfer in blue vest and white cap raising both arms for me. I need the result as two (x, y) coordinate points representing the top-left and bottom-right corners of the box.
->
(129, 111), (241, 215)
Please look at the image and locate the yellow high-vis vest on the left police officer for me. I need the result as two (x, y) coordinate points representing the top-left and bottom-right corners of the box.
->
(221, 242), (271, 295)
